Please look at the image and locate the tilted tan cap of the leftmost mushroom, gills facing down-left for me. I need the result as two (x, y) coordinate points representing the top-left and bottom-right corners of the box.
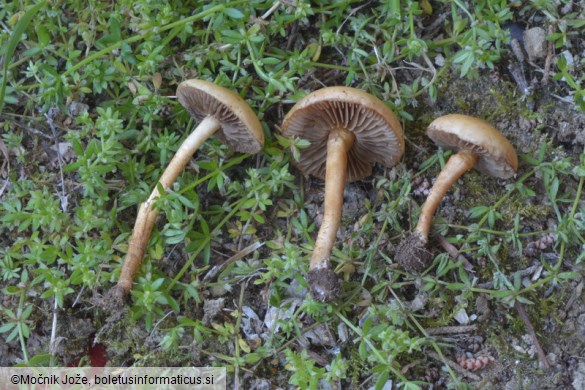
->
(177, 80), (264, 153)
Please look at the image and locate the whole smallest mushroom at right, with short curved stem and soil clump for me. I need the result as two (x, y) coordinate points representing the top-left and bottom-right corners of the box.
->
(395, 114), (518, 272)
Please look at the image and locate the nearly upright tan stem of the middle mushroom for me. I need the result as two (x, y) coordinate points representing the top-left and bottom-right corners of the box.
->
(309, 129), (355, 270)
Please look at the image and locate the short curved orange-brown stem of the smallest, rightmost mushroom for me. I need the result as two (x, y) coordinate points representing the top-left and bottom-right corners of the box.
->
(415, 150), (478, 245)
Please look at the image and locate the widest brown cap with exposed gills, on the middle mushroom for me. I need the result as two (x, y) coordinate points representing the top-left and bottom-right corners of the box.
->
(282, 87), (404, 181)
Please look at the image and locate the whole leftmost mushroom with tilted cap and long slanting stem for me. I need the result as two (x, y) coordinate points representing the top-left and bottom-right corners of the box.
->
(110, 80), (264, 306)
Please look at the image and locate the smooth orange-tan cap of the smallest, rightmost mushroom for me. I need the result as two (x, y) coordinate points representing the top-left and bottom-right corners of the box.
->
(427, 114), (518, 179)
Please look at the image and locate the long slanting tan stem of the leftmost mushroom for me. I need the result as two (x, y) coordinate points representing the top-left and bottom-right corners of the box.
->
(118, 116), (221, 293)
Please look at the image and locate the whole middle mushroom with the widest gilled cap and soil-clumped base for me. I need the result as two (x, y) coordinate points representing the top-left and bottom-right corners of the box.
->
(281, 87), (404, 301)
